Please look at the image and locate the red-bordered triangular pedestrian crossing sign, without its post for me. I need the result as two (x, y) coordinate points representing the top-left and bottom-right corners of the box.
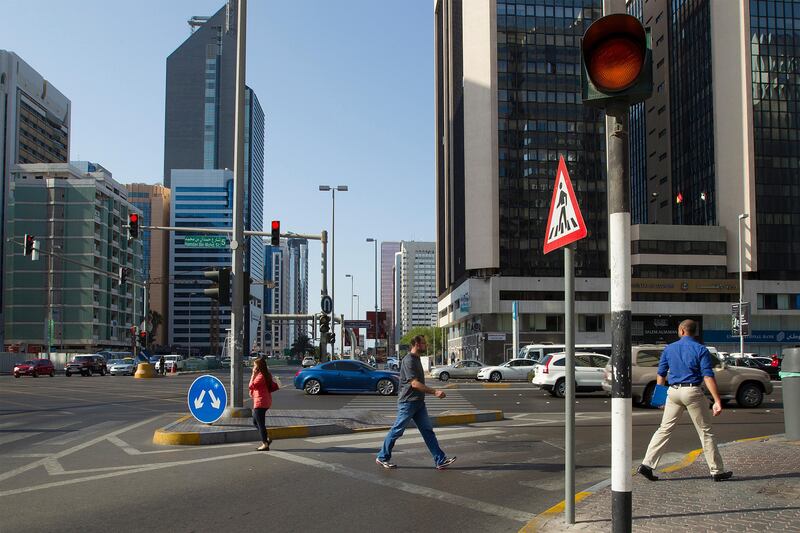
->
(544, 156), (586, 254)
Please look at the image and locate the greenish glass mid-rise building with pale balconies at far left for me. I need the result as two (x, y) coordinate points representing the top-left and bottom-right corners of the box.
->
(4, 161), (144, 352)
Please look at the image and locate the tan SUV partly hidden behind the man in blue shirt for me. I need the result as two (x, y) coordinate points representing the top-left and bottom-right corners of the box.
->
(603, 344), (772, 408)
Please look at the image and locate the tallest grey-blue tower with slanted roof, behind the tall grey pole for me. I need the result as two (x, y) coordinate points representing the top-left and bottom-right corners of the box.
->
(164, 2), (264, 354)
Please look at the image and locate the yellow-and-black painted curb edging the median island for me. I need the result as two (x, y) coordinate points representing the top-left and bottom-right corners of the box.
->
(153, 411), (504, 446)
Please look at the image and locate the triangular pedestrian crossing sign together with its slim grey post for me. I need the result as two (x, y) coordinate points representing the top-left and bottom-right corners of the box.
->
(544, 156), (587, 524)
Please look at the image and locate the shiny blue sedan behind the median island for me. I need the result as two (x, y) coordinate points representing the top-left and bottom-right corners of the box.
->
(294, 361), (400, 396)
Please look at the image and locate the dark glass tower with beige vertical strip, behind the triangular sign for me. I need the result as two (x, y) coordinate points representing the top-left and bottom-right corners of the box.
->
(434, 0), (608, 362)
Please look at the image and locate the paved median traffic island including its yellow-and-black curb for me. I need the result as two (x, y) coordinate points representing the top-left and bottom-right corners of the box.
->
(153, 409), (503, 445)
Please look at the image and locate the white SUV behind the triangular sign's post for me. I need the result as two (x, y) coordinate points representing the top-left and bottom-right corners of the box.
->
(531, 352), (610, 398)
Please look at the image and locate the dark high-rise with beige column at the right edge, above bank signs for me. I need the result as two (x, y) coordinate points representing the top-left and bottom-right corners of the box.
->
(628, 0), (800, 353)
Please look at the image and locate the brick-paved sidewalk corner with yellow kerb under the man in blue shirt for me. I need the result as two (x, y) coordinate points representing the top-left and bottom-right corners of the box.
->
(521, 436), (800, 533)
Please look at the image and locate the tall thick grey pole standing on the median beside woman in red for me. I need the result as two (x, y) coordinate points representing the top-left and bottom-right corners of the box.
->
(226, 0), (250, 418)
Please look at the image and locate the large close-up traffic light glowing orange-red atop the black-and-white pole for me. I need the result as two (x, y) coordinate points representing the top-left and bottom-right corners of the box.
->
(581, 13), (653, 111)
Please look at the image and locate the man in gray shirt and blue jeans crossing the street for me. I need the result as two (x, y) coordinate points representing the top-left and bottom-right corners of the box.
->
(375, 335), (456, 470)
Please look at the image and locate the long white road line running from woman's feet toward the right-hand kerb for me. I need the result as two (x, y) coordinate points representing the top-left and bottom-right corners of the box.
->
(268, 451), (535, 522)
